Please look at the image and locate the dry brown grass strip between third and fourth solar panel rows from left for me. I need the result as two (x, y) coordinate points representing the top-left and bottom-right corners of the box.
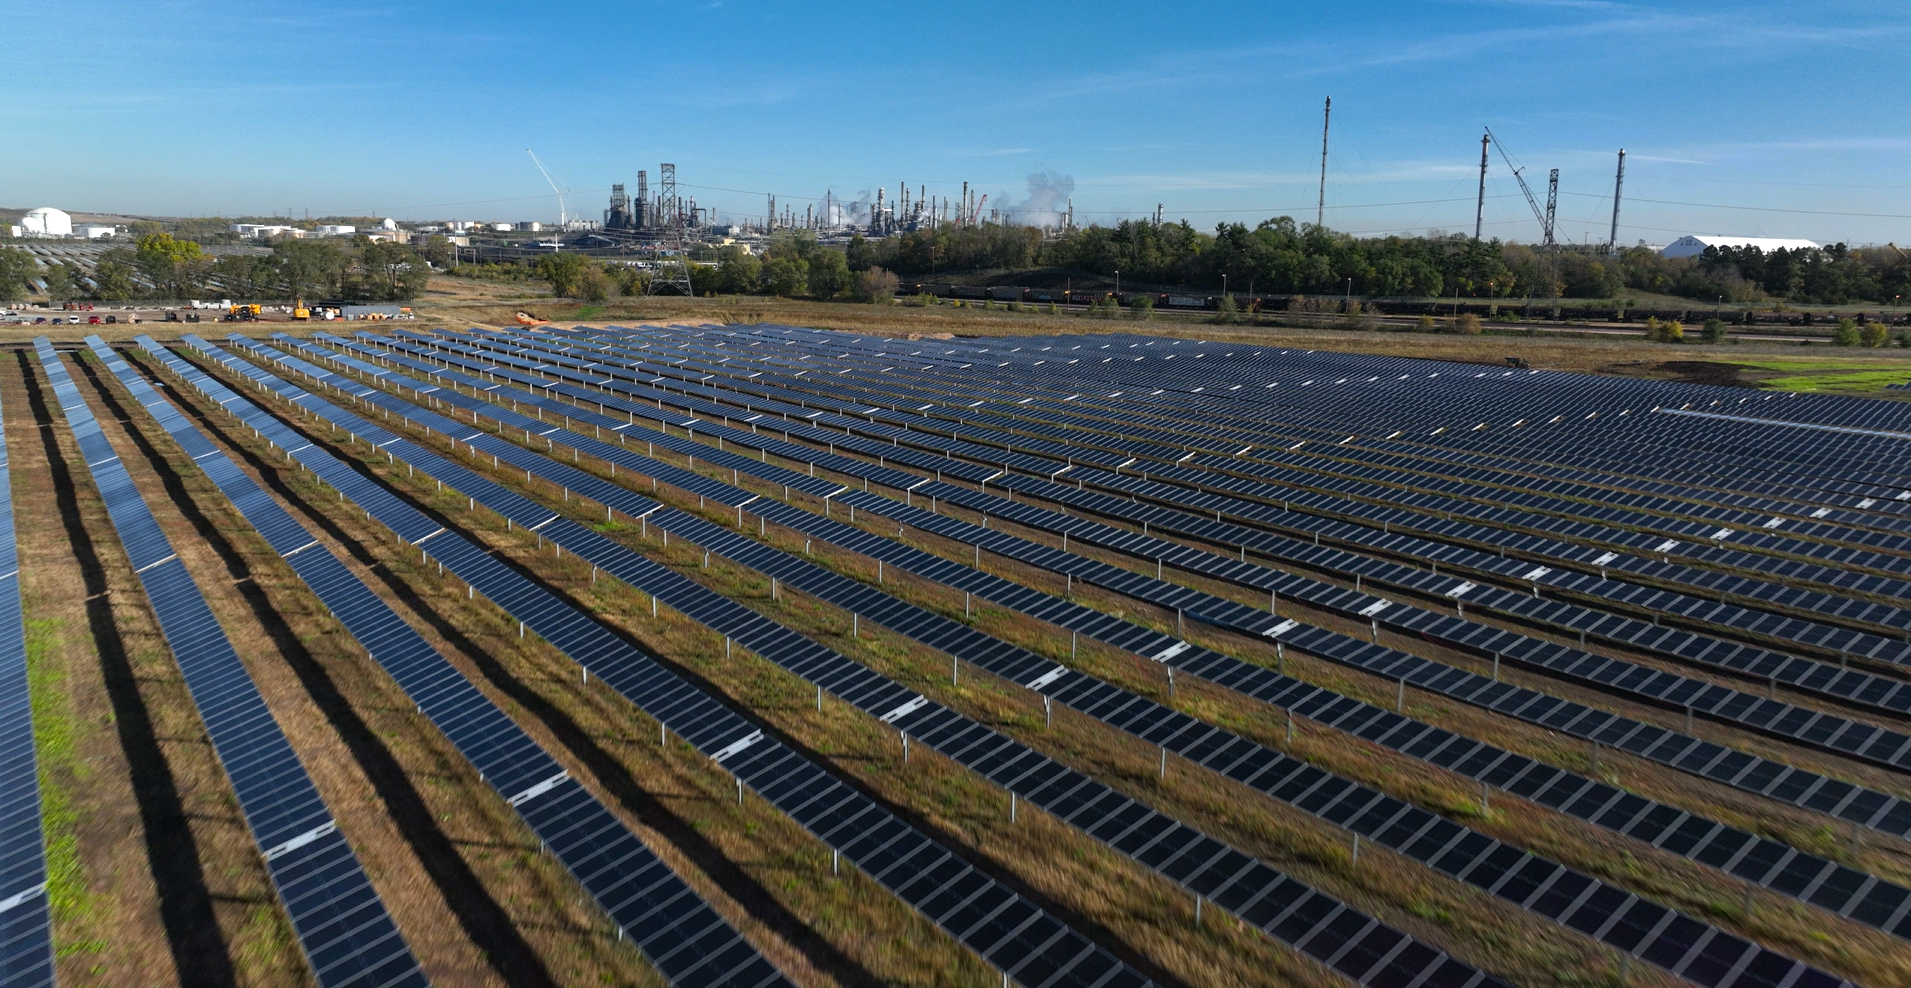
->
(139, 343), (1024, 986)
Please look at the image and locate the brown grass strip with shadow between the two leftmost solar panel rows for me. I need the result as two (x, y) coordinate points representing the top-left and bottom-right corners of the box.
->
(4, 349), (310, 988)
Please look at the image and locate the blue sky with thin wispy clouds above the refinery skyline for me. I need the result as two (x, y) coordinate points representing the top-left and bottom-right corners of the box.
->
(14, 0), (1911, 243)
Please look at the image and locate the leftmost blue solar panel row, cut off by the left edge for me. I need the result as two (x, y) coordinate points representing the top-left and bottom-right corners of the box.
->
(0, 363), (54, 988)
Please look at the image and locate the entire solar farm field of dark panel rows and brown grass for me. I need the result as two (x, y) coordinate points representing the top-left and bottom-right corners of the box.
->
(0, 319), (1911, 988)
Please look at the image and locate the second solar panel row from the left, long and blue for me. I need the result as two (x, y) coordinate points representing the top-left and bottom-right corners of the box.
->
(34, 336), (428, 988)
